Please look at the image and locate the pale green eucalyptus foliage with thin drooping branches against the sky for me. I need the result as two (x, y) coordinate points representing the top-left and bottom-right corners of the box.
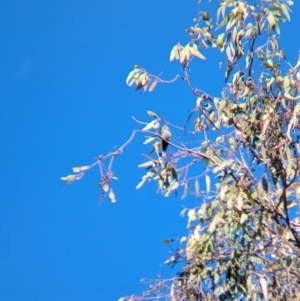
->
(63, 0), (300, 301)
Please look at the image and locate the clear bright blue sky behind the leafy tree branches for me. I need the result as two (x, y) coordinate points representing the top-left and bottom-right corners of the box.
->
(0, 0), (300, 301)
